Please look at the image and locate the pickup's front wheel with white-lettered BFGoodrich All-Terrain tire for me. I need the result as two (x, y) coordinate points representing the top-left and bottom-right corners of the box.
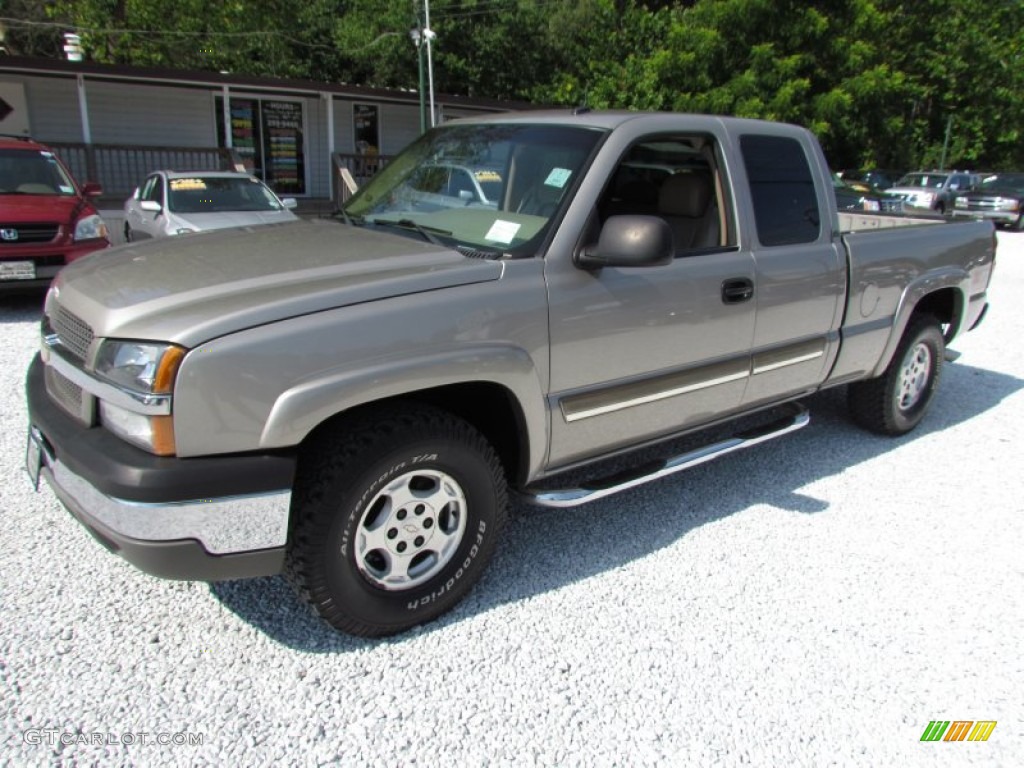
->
(286, 406), (508, 637)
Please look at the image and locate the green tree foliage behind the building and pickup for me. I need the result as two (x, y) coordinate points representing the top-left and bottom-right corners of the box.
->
(0, 0), (1024, 169)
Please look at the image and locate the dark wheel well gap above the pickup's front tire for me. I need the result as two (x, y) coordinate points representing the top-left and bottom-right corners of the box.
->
(303, 382), (528, 483)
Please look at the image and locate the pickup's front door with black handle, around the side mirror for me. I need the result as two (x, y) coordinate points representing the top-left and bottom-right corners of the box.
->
(545, 124), (756, 466)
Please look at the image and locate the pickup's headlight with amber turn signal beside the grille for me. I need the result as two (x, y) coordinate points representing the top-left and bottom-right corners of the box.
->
(95, 340), (185, 456)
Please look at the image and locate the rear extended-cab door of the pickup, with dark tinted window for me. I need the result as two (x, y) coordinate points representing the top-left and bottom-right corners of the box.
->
(737, 134), (847, 407)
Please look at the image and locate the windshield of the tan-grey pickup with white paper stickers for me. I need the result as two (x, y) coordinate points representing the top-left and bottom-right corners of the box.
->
(344, 123), (603, 253)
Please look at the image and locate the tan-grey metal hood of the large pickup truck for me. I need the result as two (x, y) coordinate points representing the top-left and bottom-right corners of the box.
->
(47, 219), (503, 347)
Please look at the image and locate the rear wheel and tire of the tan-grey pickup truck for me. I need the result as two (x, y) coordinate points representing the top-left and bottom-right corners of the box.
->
(848, 314), (945, 435)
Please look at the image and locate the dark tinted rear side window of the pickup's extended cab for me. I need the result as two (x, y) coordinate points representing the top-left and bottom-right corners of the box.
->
(739, 134), (821, 246)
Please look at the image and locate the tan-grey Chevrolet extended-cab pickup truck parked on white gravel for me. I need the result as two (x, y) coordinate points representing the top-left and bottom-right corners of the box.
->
(27, 112), (995, 636)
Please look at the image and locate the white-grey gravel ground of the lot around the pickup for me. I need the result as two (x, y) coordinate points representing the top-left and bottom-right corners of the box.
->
(0, 232), (1024, 767)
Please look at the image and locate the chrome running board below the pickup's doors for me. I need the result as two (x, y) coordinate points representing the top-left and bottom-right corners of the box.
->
(520, 402), (811, 507)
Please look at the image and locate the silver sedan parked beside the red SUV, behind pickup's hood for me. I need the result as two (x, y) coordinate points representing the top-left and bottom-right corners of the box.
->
(125, 171), (298, 243)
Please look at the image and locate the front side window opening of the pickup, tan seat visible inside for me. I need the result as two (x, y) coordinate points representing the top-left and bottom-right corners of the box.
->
(598, 135), (734, 254)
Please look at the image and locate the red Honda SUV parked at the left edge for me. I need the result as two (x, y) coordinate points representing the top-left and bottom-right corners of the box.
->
(0, 136), (111, 292)
